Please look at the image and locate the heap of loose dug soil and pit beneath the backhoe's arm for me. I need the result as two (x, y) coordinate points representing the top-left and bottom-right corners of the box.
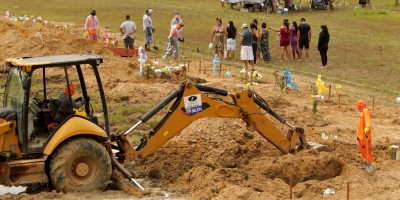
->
(125, 119), (350, 199)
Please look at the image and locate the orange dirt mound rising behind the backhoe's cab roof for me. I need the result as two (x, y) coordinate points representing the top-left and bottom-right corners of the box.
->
(0, 20), (111, 62)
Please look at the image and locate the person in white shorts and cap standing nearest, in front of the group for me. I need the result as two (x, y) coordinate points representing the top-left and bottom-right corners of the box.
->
(240, 24), (254, 84)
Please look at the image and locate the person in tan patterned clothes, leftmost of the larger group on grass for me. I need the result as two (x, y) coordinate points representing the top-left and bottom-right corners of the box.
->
(211, 18), (228, 59)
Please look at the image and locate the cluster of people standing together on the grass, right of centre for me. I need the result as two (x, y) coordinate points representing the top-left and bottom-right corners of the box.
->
(210, 18), (330, 83)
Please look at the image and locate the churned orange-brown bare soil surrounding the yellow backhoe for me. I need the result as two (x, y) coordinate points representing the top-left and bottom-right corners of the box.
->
(0, 21), (400, 199)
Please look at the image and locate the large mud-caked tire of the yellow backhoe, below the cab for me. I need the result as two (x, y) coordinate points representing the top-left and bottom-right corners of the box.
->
(49, 138), (112, 192)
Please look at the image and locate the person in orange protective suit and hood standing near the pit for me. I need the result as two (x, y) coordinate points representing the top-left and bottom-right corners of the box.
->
(356, 101), (374, 169)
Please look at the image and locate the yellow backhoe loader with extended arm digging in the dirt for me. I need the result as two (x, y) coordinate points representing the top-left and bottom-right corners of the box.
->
(0, 54), (324, 192)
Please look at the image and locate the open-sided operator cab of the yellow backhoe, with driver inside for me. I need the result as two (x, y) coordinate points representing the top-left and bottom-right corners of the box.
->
(3, 54), (109, 155)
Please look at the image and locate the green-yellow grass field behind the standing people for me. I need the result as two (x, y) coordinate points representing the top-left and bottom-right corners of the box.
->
(0, 0), (400, 101)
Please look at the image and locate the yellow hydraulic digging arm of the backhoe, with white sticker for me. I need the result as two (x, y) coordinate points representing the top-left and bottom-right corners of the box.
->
(111, 82), (310, 162)
